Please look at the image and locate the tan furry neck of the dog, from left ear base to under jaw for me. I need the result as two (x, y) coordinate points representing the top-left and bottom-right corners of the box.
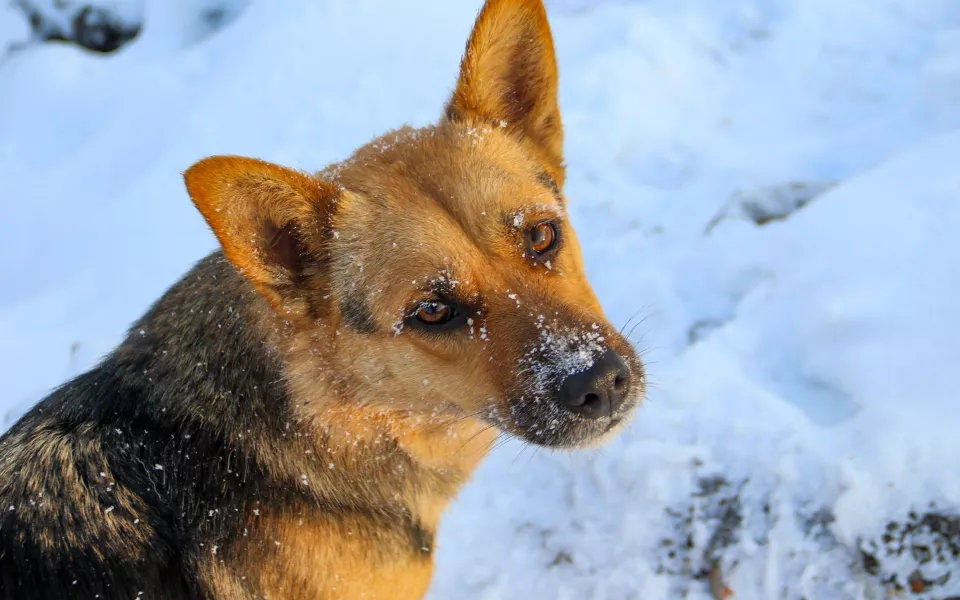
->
(244, 258), (499, 531)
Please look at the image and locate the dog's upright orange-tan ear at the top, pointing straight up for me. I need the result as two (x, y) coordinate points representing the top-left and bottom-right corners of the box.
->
(447, 0), (563, 175)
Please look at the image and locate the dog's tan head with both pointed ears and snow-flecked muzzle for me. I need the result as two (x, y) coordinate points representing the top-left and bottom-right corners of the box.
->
(186, 0), (645, 447)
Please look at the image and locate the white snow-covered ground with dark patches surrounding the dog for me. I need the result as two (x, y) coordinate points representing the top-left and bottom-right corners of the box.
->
(0, 0), (960, 600)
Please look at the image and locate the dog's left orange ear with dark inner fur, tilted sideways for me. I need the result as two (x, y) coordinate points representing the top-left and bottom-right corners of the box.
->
(184, 156), (340, 307)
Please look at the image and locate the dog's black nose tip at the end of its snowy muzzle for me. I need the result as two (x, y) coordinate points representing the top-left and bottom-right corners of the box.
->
(560, 350), (630, 419)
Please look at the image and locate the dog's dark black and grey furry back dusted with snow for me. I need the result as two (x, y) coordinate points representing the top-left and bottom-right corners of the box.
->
(0, 255), (278, 599)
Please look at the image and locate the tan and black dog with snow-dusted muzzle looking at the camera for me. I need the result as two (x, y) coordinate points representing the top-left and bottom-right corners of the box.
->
(0, 0), (645, 600)
